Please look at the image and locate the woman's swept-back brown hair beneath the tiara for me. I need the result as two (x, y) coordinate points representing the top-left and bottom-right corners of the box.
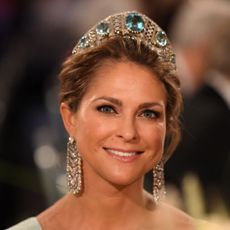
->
(59, 37), (182, 160)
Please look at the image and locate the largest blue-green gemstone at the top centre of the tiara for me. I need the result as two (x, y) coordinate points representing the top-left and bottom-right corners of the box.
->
(125, 13), (145, 33)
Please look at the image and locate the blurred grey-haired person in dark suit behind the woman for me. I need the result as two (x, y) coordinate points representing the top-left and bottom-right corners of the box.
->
(163, 0), (230, 217)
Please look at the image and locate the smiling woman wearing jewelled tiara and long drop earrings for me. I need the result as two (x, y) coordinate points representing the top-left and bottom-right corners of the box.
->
(7, 12), (223, 230)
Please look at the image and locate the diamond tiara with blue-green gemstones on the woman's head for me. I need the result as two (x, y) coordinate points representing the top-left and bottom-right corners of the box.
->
(72, 11), (176, 69)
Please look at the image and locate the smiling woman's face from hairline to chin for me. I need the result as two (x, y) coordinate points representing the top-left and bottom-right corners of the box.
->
(61, 61), (167, 190)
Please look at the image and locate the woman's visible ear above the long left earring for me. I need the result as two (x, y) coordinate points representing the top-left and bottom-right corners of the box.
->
(60, 102), (76, 136)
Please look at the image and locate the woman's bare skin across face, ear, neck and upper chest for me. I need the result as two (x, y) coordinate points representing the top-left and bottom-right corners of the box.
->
(38, 60), (194, 230)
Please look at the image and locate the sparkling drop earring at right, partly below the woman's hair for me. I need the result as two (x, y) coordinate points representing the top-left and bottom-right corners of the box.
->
(153, 160), (166, 203)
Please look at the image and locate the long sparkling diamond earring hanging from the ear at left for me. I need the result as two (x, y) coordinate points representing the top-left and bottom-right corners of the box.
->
(66, 137), (82, 195)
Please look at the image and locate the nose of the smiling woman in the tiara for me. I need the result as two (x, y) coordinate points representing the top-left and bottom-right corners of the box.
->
(117, 117), (139, 142)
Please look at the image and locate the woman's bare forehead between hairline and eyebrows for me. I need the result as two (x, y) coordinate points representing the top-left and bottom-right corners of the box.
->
(82, 60), (167, 102)
